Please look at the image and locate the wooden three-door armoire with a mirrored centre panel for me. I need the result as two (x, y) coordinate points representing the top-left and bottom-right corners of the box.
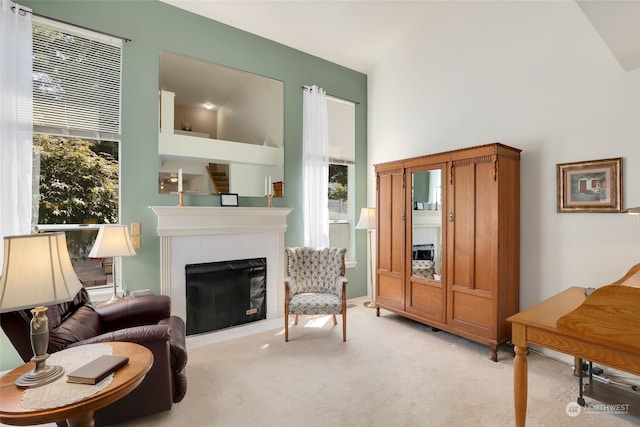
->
(375, 143), (521, 361)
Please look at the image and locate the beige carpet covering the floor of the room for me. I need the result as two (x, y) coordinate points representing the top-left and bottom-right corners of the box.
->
(12, 300), (640, 427)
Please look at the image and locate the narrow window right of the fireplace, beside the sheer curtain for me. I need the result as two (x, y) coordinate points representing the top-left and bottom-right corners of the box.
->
(327, 96), (355, 259)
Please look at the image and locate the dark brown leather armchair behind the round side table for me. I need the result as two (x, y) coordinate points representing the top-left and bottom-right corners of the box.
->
(0, 288), (187, 426)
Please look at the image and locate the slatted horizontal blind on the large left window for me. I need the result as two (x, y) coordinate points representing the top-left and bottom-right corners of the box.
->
(33, 18), (122, 141)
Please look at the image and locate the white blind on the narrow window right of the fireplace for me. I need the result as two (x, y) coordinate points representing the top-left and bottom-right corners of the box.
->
(327, 96), (356, 164)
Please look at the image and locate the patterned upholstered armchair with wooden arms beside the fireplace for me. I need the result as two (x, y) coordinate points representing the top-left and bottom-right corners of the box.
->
(284, 247), (347, 342)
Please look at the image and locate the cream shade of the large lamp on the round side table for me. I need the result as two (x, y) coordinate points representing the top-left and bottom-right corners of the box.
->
(0, 232), (82, 313)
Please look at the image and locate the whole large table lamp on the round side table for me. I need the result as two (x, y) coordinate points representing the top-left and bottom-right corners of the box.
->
(0, 232), (82, 388)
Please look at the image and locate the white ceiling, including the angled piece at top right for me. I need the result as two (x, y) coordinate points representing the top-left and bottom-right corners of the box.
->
(161, 0), (640, 73)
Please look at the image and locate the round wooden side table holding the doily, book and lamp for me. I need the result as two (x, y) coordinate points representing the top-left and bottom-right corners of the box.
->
(0, 342), (153, 427)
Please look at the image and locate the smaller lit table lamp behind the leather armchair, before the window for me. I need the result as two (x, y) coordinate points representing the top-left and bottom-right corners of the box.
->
(89, 224), (136, 304)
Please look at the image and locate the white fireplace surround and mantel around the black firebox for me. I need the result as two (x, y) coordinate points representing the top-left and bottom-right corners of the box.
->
(151, 206), (291, 332)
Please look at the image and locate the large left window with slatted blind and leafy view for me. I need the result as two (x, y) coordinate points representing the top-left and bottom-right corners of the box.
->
(33, 17), (122, 296)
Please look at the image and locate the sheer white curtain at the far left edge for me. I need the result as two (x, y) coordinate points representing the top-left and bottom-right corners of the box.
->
(0, 0), (33, 268)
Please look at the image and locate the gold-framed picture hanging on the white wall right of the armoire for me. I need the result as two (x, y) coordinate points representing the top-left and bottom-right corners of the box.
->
(557, 157), (622, 213)
